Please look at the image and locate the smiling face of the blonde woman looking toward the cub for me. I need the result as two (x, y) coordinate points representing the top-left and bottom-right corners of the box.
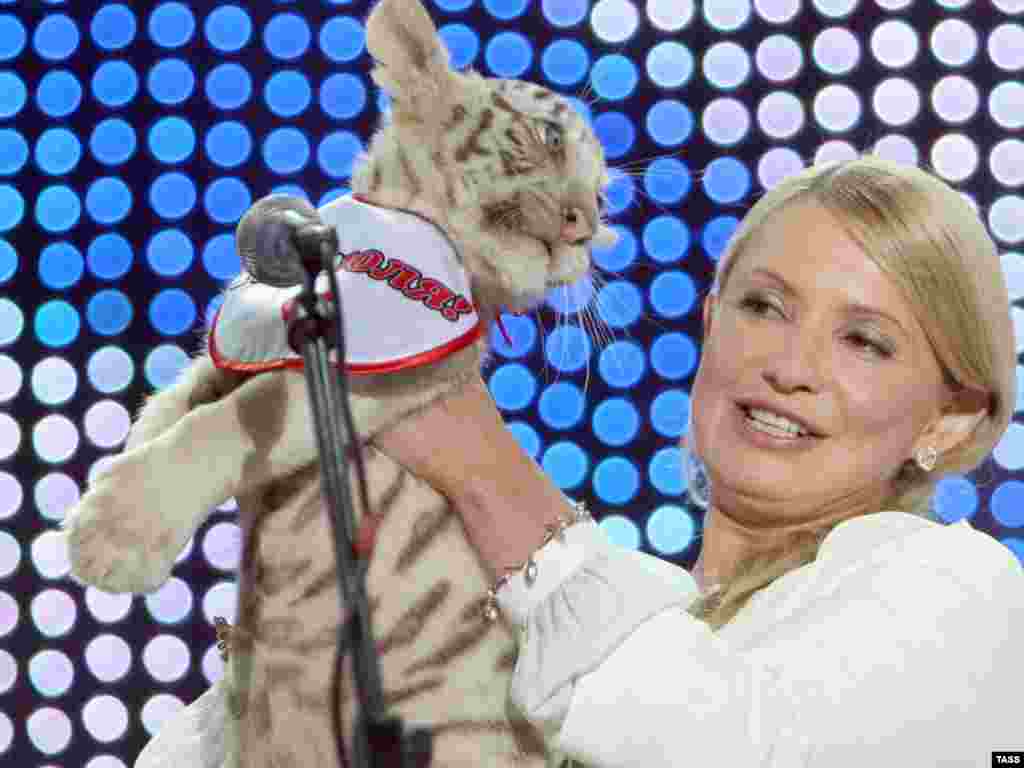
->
(690, 203), (950, 527)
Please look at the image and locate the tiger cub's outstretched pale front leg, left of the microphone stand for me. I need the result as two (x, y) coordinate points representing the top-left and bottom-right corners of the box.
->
(65, 372), (348, 592)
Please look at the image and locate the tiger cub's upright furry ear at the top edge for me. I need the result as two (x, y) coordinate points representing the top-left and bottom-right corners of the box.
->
(367, 0), (455, 120)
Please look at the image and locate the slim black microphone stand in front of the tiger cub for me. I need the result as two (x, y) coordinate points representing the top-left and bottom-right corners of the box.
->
(288, 226), (433, 768)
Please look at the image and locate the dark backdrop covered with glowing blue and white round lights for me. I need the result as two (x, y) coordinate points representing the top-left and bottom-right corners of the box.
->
(0, 0), (1024, 768)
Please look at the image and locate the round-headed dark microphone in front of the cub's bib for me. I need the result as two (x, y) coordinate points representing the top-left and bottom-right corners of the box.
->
(234, 195), (338, 288)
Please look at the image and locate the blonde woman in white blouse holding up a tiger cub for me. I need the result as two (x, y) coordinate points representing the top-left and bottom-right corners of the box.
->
(378, 157), (1024, 768)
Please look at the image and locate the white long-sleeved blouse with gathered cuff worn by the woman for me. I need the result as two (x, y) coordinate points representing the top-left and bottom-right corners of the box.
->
(498, 512), (1024, 768)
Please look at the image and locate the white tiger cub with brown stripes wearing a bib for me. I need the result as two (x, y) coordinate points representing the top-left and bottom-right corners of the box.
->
(63, 0), (614, 768)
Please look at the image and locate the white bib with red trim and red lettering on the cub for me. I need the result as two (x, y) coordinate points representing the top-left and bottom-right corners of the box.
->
(209, 196), (481, 374)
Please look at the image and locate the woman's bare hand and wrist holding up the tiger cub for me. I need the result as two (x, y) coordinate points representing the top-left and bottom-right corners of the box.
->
(374, 379), (566, 578)
